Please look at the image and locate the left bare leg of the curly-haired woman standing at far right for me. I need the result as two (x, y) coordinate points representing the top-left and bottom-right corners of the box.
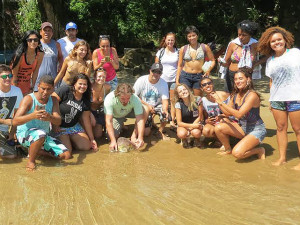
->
(272, 109), (288, 166)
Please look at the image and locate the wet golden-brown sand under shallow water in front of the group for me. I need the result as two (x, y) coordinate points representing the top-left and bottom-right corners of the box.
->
(0, 73), (300, 225)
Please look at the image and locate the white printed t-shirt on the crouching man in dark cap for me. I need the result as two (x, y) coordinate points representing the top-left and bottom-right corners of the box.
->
(133, 75), (169, 107)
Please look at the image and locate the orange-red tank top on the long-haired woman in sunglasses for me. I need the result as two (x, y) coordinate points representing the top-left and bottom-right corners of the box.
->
(17, 52), (39, 95)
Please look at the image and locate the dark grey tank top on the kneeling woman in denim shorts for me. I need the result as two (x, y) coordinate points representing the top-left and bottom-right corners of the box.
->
(233, 91), (263, 125)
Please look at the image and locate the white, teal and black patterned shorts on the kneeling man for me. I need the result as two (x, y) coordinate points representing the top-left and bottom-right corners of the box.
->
(17, 128), (68, 157)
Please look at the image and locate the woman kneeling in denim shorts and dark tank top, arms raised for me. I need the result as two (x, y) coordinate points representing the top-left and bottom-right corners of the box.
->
(212, 67), (267, 159)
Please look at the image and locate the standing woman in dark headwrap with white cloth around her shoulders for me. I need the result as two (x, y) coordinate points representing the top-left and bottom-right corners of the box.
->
(219, 20), (261, 93)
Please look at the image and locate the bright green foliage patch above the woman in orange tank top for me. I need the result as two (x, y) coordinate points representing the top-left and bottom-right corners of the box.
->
(16, 0), (42, 33)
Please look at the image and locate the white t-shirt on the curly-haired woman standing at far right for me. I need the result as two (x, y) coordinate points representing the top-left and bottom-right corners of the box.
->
(266, 48), (300, 101)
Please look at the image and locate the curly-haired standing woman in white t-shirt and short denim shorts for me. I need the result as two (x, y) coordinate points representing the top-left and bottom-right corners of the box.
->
(258, 27), (300, 170)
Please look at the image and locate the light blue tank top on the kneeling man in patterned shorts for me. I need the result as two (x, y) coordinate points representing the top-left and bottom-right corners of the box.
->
(17, 93), (53, 133)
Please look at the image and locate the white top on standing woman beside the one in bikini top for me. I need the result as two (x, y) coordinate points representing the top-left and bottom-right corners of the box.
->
(156, 48), (179, 82)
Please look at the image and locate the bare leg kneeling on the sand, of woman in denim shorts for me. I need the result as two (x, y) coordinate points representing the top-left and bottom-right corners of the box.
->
(232, 135), (266, 159)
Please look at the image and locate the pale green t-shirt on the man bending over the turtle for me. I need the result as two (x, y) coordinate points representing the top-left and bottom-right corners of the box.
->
(104, 91), (143, 118)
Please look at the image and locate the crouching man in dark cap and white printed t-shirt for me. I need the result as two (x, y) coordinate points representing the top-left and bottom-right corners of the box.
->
(133, 63), (169, 140)
